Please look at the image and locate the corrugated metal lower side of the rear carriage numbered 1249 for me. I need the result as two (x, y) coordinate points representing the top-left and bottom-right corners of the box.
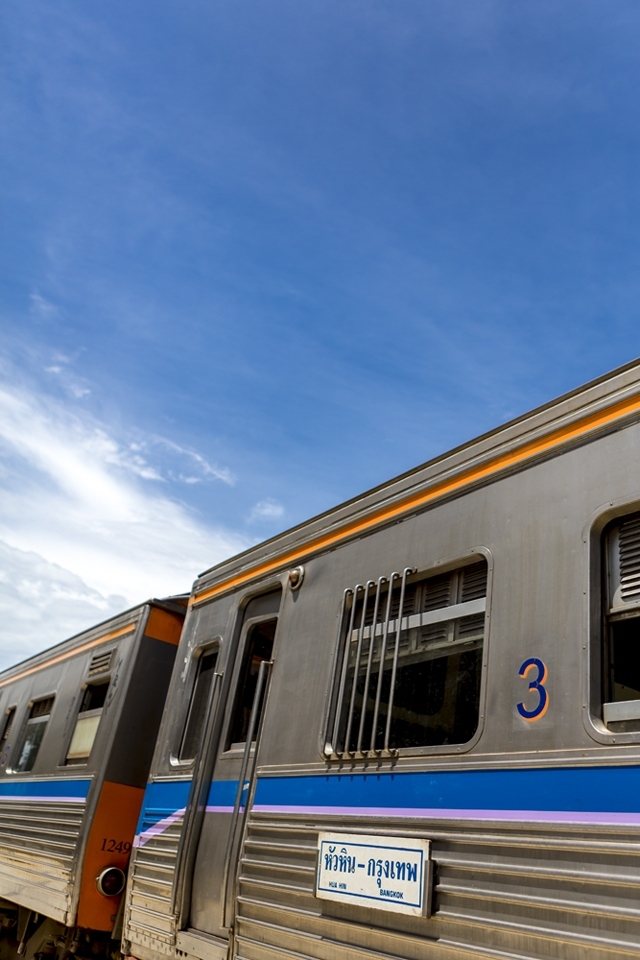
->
(0, 798), (85, 922)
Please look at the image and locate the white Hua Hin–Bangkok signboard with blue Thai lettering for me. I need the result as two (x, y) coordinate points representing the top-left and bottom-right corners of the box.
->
(316, 833), (430, 917)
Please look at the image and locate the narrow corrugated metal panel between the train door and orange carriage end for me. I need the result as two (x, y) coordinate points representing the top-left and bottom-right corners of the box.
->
(124, 809), (183, 954)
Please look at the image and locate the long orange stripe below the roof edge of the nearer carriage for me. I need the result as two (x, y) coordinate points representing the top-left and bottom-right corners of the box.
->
(189, 386), (640, 605)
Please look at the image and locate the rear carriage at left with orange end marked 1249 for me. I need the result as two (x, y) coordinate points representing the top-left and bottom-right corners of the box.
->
(0, 597), (186, 960)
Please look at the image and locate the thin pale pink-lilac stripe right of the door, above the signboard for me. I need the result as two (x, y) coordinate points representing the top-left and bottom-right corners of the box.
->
(253, 803), (640, 826)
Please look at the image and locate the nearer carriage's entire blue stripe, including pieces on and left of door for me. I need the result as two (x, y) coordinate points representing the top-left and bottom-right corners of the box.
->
(138, 766), (640, 832)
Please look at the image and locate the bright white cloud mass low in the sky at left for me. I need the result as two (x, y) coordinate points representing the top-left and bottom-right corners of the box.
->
(0, 385), (248, 659)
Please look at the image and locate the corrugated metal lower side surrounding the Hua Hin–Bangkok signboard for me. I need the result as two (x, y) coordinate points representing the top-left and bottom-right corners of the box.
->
(236, 814), (640, 960)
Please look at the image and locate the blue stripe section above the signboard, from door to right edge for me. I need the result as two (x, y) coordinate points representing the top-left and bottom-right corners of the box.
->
(255, 766), (640, 813)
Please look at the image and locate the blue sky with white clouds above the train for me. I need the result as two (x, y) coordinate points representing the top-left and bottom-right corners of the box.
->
(0, 0), (640, 667)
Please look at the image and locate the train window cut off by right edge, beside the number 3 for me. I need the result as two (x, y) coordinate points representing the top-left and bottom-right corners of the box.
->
(603, 514), (640, 731)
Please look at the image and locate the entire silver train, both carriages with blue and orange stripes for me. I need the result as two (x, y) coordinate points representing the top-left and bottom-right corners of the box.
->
(0, 361), (640, 960)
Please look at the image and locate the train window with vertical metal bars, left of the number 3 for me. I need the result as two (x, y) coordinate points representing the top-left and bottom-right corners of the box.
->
(325, 559), (487, 756)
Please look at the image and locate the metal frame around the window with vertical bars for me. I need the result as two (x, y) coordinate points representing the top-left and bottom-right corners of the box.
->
(318, 546), (493, 765)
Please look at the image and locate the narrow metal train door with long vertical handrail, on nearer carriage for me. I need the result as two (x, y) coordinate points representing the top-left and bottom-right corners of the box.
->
(177, 590), (281, 960)
